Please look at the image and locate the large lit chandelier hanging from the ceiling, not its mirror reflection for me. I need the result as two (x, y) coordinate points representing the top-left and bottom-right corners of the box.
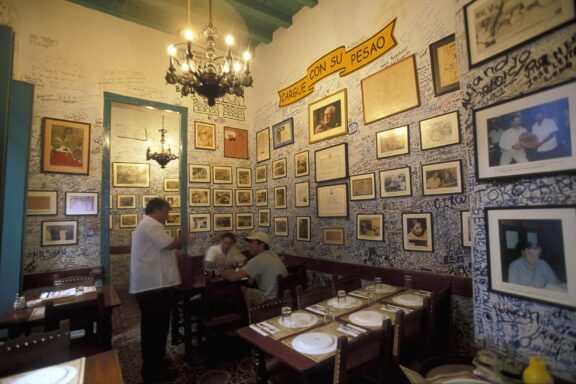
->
(166, 0), (252, 106)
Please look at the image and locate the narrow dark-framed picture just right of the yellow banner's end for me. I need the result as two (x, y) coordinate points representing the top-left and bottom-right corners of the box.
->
(430, 34), (460, 97)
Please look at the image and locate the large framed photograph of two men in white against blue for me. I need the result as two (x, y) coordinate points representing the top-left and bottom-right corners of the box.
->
(474, 81), (576, 180)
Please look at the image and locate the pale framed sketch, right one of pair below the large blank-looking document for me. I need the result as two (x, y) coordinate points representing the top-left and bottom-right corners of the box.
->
(420, 111), (460, 150)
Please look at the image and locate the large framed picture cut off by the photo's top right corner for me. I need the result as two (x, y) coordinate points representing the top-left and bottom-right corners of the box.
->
(464, 0), (575, 67)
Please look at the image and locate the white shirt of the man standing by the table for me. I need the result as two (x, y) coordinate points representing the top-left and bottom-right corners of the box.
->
(130, 215), (180, 293)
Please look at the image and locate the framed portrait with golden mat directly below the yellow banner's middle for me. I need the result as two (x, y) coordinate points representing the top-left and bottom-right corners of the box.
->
(308, 89), (348, 144)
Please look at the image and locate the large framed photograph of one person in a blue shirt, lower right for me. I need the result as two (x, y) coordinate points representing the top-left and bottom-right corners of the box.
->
(485, 206), (576, 308)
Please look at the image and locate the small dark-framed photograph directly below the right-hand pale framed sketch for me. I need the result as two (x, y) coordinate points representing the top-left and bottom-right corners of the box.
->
(422, 160), (462, 196)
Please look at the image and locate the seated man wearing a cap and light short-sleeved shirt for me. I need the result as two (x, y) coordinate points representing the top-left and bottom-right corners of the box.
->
(220, 232), (288, 305)
